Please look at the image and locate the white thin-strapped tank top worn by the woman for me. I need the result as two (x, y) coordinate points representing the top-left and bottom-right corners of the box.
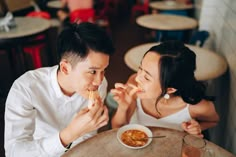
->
(130, 99), (192, 131)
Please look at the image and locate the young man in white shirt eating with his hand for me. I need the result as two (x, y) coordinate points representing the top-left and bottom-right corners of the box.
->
(5, 23), (114, 157)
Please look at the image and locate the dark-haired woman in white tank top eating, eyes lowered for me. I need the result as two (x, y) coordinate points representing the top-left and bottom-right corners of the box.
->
(111, 41), (219, 137)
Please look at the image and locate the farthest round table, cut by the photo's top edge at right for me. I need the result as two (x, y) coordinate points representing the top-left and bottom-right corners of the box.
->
(149, 1), (193, 10)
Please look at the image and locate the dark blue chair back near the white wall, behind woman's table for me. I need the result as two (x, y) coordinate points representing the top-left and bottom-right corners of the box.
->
(189, 30), (210, 47)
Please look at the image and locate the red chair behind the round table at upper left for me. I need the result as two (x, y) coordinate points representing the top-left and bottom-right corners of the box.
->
(24, 11), (51, 68)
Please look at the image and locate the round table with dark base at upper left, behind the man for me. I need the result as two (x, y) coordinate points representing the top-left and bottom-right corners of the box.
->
(0, 17), (51, 77)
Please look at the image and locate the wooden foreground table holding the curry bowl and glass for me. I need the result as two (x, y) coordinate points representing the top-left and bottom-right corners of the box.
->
(62, 127), (234, 157)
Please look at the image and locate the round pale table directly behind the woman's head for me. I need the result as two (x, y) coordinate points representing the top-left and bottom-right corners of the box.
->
(124, 43), (227, 81)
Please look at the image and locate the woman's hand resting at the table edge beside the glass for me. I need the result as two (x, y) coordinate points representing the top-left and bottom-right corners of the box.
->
(181, 119), (203, 138)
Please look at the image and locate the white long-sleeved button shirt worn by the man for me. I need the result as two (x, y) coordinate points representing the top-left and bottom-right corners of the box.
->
(4, 66), (107, 157)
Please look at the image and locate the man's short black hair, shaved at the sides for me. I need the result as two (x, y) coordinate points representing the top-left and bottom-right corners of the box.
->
(57, 22), (114, 62)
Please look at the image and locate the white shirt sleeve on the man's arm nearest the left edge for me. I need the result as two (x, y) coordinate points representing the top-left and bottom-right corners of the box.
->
(4, 82), (65, 157)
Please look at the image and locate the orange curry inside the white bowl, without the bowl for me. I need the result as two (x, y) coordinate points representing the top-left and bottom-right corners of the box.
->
(121, 130), (148, 147)
